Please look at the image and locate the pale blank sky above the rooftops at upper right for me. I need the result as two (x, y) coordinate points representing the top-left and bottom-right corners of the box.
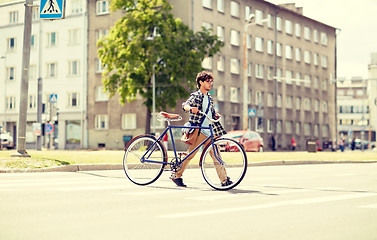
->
(267, 0), (377, 79)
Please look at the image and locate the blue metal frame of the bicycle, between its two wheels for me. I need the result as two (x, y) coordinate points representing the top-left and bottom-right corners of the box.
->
(141, 121), (225, 168)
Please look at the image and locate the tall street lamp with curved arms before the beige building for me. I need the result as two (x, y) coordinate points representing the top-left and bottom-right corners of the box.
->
(242, 14), (268, 130)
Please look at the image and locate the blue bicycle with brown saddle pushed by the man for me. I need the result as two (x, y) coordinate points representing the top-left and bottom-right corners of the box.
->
(123, 112), (247, 190)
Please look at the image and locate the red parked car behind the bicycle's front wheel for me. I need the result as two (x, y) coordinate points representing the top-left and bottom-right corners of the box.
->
(223, 130), (264, 152)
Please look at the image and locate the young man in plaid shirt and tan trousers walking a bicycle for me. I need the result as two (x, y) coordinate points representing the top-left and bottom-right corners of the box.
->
(172, 71), (233, 187)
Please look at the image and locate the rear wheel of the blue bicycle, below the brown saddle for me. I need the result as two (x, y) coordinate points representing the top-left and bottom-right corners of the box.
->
(123, 135), (167, 185)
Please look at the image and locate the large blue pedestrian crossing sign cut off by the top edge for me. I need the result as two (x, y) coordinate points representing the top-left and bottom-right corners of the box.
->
(39, 0), (65, 20)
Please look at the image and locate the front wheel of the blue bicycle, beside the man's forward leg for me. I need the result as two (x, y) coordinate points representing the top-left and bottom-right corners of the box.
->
(200, 138), (247, 190)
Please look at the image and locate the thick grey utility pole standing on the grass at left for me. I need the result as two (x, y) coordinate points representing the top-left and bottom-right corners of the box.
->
(11, 0), (33, 157)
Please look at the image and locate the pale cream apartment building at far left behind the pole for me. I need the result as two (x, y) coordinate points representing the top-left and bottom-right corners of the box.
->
(0, 0), (87, 149)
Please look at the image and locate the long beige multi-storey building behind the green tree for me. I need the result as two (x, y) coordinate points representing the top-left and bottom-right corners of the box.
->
(88, 0), (336, 150)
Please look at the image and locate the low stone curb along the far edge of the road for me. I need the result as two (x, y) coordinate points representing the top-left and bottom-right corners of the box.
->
(0, 160), (377, 173)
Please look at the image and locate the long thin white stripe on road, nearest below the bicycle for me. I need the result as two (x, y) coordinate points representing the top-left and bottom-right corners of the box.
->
(156, 193), (377, 218)
